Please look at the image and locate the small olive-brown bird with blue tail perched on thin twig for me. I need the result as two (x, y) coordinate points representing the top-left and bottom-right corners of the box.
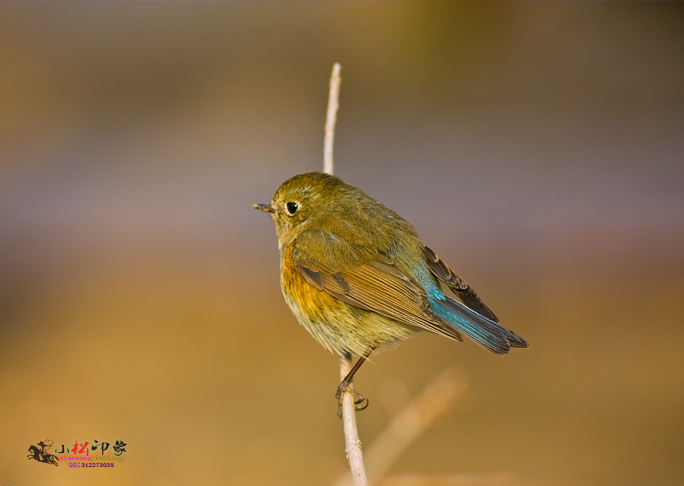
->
(253, 172), (528, 409)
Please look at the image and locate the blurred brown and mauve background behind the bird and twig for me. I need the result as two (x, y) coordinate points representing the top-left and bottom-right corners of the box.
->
(0, 2), (684, 486)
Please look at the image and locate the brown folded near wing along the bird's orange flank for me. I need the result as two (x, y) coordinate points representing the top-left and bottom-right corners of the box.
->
(293, 251), (462, 341)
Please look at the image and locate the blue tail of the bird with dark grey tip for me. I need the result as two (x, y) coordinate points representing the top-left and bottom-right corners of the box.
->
(430, 296), (529, 355)
